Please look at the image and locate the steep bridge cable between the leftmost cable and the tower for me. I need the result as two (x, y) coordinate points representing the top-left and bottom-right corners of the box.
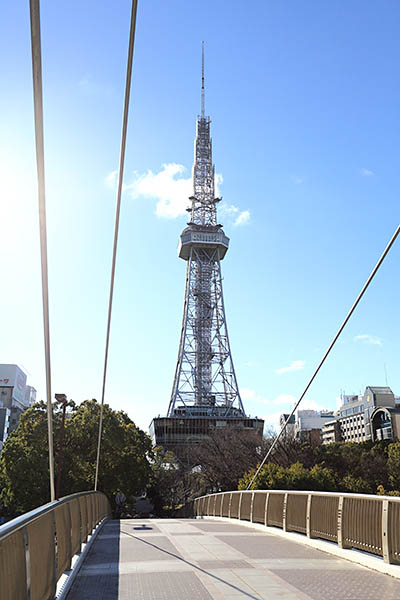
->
(94, 0), (138, 490)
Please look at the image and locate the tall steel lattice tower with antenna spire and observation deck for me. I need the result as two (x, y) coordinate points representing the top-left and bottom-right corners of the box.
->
(150, 50), (264, 457)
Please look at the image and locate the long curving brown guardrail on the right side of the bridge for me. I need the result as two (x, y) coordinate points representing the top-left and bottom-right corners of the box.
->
(194, 490), (400, 564)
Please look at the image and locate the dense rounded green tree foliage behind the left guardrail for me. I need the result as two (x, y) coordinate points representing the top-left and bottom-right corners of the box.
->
(0, 400), (152, 514)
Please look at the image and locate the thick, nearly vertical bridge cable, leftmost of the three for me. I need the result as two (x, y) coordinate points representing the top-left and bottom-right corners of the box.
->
(30, 0), (55, 502)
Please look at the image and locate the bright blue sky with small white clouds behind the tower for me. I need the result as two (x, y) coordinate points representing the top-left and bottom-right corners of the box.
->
(0, 0), (400, 428)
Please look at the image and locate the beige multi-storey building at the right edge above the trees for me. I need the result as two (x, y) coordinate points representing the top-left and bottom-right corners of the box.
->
(322, 386), (400, 444)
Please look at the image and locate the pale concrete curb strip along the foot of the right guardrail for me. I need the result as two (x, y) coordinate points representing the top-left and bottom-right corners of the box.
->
(196, 516), (400, 579)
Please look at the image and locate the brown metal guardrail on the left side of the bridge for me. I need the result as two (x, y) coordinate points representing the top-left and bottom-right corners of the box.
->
(0, 492), (111, 600)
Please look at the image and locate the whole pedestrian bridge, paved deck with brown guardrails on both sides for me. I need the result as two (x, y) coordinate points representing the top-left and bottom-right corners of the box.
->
(0, 492), (400, 600)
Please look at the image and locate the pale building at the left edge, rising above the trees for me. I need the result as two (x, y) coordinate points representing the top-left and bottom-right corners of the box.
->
(0, 364), (32, 433)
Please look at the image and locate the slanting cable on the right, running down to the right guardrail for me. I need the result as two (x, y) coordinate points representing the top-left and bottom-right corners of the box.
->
(246, 225), (400, 490)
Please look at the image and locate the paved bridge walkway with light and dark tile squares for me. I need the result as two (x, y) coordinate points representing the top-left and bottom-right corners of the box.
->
(67, 519), (400, 600)
